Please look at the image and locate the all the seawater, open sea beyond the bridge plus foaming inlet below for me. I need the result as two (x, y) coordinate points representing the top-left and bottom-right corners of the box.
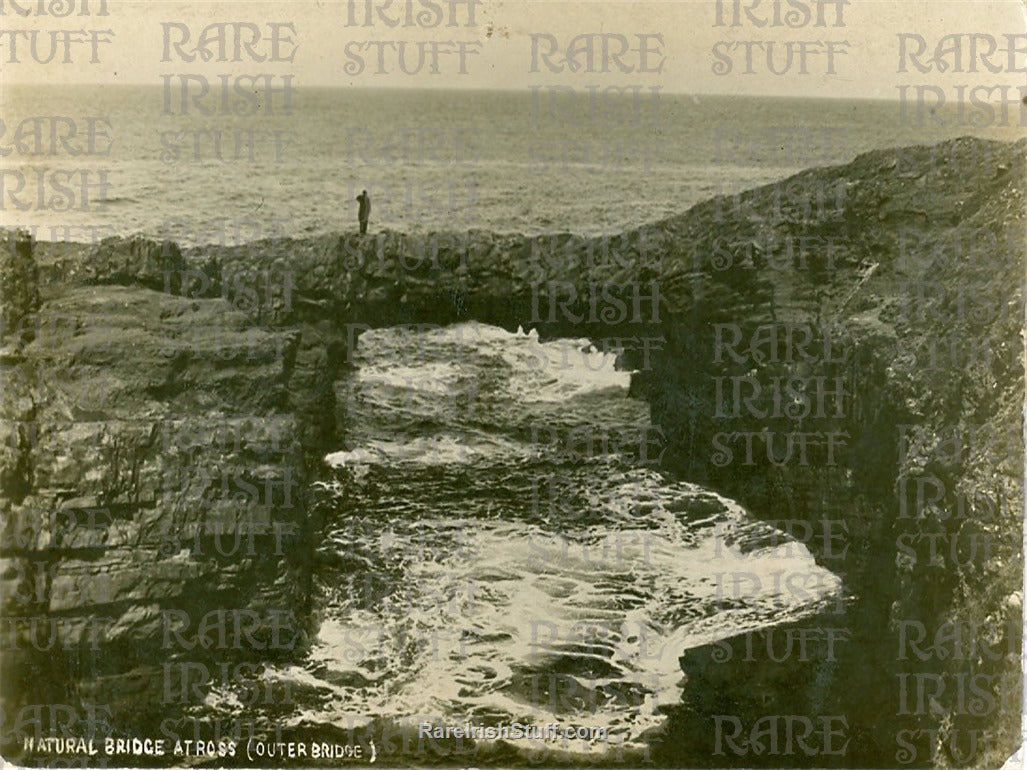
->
(0, 85), (1022, 762)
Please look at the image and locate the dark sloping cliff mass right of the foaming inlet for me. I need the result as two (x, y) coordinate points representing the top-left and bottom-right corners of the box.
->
(647, 140), (1025, 767)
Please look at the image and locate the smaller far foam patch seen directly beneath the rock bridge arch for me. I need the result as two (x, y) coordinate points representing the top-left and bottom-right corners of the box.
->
(325, 322), (646, 467)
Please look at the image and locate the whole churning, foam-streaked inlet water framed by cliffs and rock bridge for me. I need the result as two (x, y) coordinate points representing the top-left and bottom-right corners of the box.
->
(269, 323), (840, 755)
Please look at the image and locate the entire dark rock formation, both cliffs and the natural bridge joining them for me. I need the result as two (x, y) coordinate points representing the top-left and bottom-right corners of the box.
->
(0, 140), (1027, 767)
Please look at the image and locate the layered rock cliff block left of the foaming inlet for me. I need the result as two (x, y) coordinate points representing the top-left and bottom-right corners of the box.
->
(0, 234), (310, 735)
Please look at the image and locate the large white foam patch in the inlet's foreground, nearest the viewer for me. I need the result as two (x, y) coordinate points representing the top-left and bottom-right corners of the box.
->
(295, 471), (840, 759)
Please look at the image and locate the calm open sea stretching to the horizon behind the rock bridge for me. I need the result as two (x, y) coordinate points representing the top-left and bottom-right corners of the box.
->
(2, 86), (1018, 243)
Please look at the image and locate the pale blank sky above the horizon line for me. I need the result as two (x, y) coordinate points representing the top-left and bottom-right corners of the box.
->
(0, 0), (1027, 101)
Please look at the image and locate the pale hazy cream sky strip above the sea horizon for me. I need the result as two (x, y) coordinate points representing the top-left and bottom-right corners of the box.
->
(0, 0), (1027, 99)
